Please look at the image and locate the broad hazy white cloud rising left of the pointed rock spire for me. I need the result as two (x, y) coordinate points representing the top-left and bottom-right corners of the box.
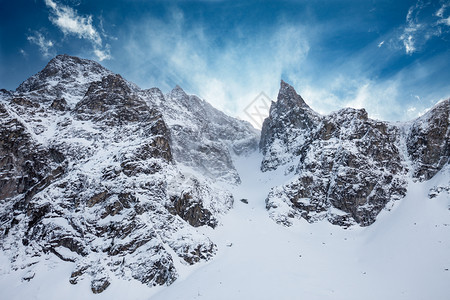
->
(121, 9), (309, 126)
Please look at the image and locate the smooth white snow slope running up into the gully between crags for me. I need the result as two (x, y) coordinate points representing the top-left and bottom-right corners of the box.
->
(0, 153), (450, 300)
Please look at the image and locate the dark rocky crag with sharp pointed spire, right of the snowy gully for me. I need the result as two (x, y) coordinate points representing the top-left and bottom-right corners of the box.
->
(260, 82), (449, 226)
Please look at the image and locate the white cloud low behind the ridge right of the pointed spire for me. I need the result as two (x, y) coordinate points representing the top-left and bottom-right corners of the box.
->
(295, 50), (450, 121)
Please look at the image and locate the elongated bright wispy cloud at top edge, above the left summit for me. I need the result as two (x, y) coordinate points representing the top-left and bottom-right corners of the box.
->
(45, 0), (111, 61)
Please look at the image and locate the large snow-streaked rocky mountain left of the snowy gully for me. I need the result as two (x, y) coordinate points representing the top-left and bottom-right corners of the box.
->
(0, 55), (248, 293)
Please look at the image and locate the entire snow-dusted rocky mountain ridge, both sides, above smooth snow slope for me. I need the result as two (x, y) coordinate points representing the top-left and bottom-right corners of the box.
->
(0, 55), (449, 293)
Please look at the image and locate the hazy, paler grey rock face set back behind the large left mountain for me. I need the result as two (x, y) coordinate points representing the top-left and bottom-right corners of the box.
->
(142, 86), (259, 183)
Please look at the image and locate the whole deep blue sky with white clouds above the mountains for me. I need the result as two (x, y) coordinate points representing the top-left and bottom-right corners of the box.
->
(0, 0), (450, 125)
